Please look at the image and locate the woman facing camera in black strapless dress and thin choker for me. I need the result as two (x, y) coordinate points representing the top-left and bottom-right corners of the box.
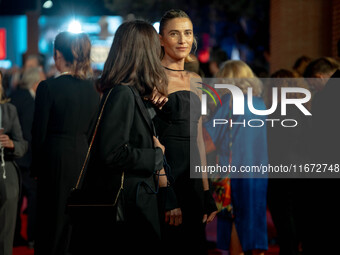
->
(154, 10), (217, 254)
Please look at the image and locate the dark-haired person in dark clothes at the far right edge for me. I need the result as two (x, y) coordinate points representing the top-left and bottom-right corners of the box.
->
(304, 57), (340, 254)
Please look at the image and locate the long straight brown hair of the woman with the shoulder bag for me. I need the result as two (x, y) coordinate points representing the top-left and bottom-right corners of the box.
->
(97, 20), (168, 96)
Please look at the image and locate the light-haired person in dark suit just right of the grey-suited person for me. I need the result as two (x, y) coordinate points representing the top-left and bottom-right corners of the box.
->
(10, 67), (45, 248)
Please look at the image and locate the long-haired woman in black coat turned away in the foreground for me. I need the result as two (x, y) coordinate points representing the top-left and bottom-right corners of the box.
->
(71, 20), (167, 254)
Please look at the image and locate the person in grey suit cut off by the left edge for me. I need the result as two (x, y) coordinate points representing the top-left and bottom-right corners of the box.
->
(0, 71), (27, 255)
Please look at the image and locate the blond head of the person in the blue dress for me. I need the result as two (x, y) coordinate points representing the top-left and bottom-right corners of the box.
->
(216, 60), (263, 97)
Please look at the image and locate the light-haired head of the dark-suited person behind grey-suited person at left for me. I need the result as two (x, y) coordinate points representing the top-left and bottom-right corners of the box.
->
(19, 67), (46, 92)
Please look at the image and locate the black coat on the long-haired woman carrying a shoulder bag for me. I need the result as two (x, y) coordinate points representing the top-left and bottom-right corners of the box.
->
(73, 85), (163, 252)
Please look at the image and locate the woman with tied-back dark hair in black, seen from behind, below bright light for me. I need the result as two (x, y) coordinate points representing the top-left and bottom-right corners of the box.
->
(31, 32), (100, 255)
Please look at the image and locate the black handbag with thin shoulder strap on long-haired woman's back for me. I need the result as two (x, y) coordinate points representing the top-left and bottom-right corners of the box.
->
(66, 89), (126, 223)
